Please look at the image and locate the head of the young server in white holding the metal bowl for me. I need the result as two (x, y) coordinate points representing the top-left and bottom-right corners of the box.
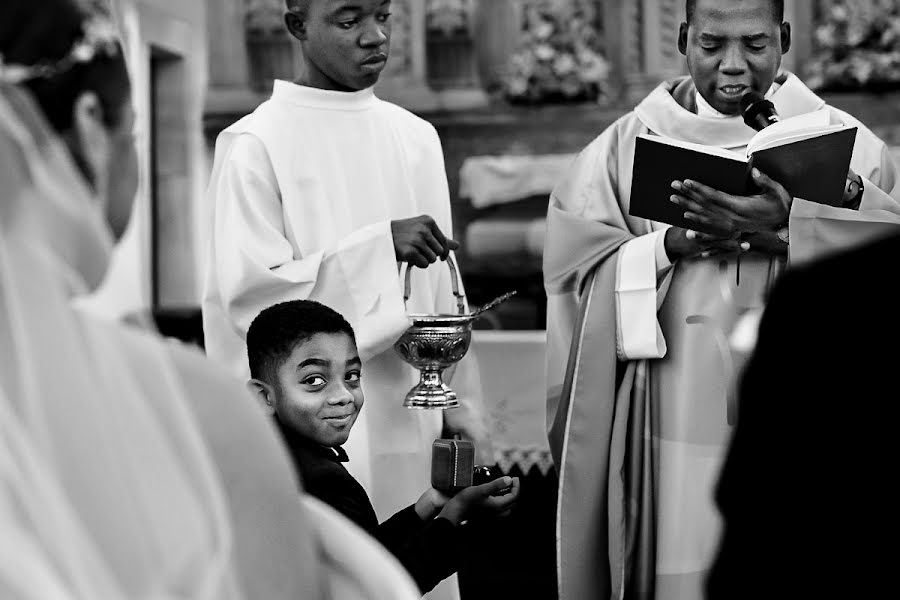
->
(285, 0), (391, 92)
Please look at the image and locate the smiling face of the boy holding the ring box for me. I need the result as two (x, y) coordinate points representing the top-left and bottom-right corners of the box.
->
(273, 333), (363, 446)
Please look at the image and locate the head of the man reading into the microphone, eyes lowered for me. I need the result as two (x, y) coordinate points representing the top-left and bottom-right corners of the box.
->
(678, 0), (791, 115)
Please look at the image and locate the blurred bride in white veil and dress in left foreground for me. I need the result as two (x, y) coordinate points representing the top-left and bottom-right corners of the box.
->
(0, 0), (415, 600)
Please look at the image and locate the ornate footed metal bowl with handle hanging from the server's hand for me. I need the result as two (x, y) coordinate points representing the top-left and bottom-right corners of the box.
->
(394, 255), (479, 409)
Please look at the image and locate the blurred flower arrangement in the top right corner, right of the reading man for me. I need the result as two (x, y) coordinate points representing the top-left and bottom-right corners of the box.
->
(807, 0), (900, 90)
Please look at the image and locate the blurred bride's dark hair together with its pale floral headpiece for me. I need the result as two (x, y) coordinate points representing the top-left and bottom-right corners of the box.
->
(0, 0), (131, 133)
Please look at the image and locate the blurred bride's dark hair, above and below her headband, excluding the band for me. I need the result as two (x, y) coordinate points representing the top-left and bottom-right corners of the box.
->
(0, 0), (131, 133)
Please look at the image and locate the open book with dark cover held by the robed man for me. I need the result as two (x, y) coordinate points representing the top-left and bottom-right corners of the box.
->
(628, 110), (856, 231)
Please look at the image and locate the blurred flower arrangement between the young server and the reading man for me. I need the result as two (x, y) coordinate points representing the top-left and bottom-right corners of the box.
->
(502, 0), (609, 104)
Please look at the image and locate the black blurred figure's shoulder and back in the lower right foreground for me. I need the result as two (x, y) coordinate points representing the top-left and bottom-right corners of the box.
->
(707, 237), (900, 600)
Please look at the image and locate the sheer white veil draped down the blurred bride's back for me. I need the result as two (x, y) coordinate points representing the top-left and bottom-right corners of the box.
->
(0, 86), (238, 598)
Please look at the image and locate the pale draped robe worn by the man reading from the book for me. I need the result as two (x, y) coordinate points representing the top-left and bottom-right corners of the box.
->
(544, 75), (900, 600)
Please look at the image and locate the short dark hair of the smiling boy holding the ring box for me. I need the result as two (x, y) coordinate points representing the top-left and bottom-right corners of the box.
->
(247, 300), (356, 385)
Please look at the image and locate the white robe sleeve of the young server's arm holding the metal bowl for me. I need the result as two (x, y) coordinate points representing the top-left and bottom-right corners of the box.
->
(209, 133), (404, 367)
